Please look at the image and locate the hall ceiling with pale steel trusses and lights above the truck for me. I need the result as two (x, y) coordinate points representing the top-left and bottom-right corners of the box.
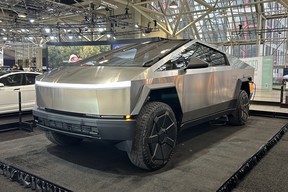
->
(0, 0), (288, 45)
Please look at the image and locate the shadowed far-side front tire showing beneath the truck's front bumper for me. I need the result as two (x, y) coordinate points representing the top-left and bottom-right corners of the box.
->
(45, 131), (82, 146)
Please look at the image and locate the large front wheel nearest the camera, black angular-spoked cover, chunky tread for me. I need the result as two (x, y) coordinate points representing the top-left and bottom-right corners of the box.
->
(128, 102), (177, 170)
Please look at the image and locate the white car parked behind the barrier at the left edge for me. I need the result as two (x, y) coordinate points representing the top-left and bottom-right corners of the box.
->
(0, 71), (40, 114)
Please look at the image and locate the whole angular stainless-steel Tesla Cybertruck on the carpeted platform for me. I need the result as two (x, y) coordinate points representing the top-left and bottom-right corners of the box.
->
(33, 39), (254, 170)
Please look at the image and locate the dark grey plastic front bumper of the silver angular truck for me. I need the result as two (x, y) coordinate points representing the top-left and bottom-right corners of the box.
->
(32, 107), (136, 141)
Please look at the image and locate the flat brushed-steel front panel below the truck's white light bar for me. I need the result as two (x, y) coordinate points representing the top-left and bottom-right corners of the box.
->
(36, 86), (130, 115)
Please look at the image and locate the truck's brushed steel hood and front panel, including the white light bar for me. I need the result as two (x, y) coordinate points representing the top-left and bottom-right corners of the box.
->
(36, 67), (143, 115)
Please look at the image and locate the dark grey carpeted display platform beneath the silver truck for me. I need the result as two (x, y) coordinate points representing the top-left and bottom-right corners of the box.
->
(0, 116), (287, 192)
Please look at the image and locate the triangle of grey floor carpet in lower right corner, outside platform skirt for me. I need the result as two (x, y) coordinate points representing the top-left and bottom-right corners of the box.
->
(233, 133), (288, 192)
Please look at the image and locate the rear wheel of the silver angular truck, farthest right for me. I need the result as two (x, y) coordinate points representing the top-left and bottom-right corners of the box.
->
(228, 90), (250, 125)
